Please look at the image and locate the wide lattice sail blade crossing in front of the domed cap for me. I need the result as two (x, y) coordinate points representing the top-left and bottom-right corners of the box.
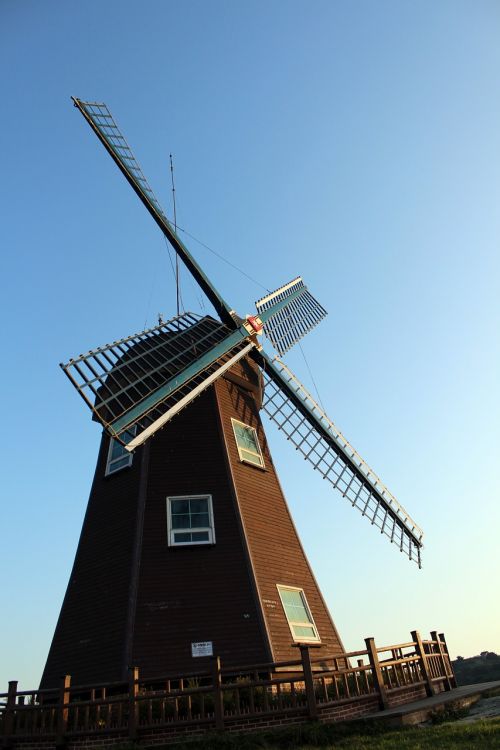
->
(61, 313), (250, 450)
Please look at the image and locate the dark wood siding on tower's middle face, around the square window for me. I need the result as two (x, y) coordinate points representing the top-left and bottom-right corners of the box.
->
(129, 388), (268, 675)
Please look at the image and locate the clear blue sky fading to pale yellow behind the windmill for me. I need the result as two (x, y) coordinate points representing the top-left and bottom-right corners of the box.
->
(0, 0), (500, 691)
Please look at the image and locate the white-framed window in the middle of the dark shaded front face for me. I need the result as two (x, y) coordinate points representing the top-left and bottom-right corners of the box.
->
(167, 495), (215, 547)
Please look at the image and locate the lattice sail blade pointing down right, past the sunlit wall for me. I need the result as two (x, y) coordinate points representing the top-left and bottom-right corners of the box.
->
(259, 352), (423, 567)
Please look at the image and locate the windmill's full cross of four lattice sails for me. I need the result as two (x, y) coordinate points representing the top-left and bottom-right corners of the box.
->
(68, 98), (423, 566)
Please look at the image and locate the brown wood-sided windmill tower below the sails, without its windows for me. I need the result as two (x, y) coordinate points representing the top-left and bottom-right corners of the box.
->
(42, 350), (342, 687)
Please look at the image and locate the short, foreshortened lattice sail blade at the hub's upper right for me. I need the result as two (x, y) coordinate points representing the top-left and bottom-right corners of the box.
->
(255, 276), (327, 356)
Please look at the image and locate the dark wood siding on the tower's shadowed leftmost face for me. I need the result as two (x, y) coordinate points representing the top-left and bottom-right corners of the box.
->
(41, 435), (141, 688)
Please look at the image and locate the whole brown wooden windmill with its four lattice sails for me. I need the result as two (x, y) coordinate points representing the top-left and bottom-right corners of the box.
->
(42, 98), (422, 687)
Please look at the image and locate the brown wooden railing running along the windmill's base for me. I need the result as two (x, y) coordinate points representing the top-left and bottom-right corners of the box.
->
(0, 631), (456, 747)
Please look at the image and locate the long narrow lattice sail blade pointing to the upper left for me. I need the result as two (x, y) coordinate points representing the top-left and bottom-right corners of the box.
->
(72, 97), (238, 329)
